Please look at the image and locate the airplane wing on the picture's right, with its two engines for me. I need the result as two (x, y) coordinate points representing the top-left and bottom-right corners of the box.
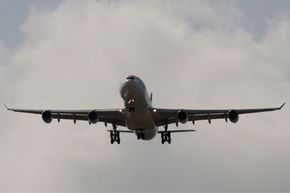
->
(152, 103), (285, 126)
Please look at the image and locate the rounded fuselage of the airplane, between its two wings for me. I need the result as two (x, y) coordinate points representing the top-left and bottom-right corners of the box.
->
(120, 76), (157, 140)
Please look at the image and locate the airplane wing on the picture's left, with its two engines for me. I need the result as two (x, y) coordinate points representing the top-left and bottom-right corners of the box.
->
(5, 105), (126, 126)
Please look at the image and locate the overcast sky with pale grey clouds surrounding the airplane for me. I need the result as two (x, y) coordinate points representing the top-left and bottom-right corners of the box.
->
(0, 0), (290, 192)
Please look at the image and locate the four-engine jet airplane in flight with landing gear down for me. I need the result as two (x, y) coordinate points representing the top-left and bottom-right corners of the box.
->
(5, 75), (285, 144)
